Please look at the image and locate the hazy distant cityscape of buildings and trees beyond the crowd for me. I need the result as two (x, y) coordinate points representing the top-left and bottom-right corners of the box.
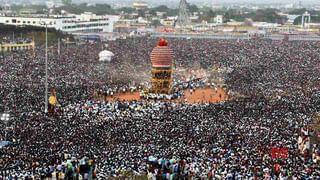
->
(0, 0), (320, 40)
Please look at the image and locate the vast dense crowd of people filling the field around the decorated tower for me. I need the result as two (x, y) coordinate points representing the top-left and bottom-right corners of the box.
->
(0, 38), (320, 180)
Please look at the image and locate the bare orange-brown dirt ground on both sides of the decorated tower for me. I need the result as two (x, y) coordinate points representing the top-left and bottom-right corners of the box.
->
(106, 88), (228, 104)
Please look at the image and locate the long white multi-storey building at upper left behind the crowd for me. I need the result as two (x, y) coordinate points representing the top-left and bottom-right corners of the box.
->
(0, 12), (119, 33)
